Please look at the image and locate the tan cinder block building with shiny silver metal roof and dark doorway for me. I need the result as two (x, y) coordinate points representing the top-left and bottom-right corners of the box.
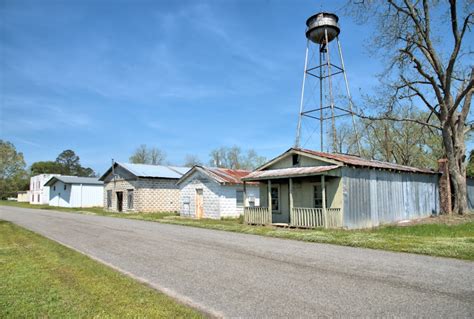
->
(99, 162), (190, 212)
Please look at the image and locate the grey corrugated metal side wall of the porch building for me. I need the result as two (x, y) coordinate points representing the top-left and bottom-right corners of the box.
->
(342, 167), (438, 228)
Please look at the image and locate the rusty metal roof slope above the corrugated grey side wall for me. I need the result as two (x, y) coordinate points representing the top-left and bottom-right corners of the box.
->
(296, 148), (437, 174)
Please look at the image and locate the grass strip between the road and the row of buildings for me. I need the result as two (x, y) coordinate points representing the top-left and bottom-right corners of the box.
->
(0, 201), (474, 260)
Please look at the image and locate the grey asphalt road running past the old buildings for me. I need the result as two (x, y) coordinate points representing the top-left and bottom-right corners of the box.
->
(0, 206), (474, 318)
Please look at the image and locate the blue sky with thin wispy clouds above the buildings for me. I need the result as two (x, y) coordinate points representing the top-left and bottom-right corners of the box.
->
(0, 0), (458, 172)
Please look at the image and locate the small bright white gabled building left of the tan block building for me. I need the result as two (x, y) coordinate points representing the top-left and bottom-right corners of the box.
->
(45, 175), (104, 207)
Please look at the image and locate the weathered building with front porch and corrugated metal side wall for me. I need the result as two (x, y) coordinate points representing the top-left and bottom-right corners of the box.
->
(243, 148), (440, 228)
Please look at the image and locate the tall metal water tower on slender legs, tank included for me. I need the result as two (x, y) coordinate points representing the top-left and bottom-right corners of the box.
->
(295, 12), (360, 155)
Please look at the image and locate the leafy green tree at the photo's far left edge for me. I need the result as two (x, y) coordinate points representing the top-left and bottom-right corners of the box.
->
(0, 140), (29, 199)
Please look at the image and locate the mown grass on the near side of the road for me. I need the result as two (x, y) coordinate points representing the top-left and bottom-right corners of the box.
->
(0, 220), (203, 318)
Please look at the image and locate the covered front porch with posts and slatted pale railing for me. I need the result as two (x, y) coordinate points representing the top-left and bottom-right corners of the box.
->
(244, 171), (343, 228)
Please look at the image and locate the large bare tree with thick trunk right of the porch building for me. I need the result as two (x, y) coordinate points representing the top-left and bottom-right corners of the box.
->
(351, 0), (474, 214)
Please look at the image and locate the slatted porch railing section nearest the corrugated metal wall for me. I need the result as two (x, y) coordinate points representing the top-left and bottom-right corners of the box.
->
(290, 207), (342, 228)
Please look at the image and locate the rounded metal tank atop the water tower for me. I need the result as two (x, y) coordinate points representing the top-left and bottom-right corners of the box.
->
(306, 12), (341, 44)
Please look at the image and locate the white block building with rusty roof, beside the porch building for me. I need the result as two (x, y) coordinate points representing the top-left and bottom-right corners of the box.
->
(178, 165), (260, 218)
